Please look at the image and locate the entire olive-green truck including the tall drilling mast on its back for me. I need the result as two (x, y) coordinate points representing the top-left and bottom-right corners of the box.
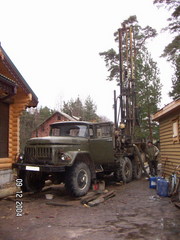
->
(13, 26), (146, 196)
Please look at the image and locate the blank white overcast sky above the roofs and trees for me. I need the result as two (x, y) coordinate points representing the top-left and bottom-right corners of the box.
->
(0, 0), (172, 120)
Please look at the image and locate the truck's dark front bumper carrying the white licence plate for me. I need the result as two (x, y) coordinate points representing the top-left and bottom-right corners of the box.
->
(12, 163), (65, 172)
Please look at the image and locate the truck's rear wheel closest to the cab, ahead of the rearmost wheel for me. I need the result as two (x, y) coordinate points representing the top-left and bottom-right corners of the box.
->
(114, 157), (132, 183)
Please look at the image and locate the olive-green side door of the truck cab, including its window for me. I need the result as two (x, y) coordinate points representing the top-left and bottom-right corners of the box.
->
(89, 123), (113, 165)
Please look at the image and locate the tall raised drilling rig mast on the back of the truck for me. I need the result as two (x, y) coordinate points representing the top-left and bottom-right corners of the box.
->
(114, 26), (147, 174)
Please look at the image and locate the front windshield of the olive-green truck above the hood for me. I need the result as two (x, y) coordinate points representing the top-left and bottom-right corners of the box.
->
(50, 124), (88, 137)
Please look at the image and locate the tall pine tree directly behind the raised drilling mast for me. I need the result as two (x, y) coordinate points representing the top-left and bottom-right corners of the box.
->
(100, 16), (161, 140)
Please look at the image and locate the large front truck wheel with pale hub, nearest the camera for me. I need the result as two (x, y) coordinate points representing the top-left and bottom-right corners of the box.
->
(65, 162), (91, 197)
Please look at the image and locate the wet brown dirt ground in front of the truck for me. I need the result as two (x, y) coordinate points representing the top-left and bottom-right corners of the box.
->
(0, 178), (180, 240)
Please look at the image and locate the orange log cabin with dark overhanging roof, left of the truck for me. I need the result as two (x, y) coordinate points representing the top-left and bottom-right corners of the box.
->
(0, 46), (38, 185)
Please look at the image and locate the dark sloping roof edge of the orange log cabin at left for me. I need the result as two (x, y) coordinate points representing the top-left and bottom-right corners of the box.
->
(0, 45), (38, 107)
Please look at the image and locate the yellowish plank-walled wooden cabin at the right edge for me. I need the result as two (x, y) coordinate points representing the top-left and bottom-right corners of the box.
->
(153, 98), (180, 177)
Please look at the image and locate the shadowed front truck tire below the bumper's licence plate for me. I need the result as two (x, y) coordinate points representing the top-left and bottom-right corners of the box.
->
(21, 171), (45, 192)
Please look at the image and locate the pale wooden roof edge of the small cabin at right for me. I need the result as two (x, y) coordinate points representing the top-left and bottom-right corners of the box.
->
(152, 98), (180, 121)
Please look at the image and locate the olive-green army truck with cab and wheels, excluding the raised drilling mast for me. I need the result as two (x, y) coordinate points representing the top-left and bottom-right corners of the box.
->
(13, 121), (142, 197)
